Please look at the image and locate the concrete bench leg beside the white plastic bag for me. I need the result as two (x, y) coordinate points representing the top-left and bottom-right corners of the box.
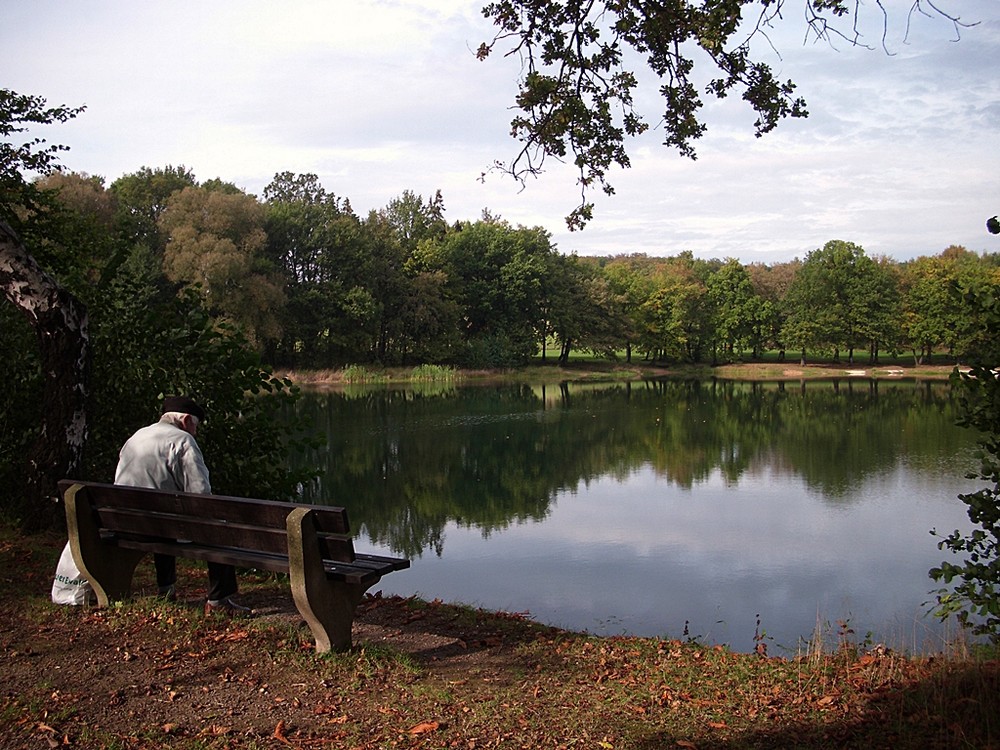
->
(63, 484), (145, 607)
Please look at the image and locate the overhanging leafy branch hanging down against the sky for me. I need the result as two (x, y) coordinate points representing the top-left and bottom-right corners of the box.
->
(477, 0), (975, 229)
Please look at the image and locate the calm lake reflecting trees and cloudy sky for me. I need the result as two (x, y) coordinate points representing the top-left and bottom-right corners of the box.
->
(288, 379), (981, 654)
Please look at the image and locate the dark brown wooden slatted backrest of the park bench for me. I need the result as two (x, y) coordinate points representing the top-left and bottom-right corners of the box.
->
(60, 481), (355, 562)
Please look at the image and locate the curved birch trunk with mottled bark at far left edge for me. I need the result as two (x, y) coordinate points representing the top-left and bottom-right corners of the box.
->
(0, 220), (90, 531)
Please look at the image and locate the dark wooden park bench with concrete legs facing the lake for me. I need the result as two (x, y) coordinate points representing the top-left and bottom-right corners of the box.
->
(59, 480), (410, 653)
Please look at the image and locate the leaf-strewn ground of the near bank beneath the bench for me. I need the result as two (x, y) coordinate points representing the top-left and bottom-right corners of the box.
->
(0, 527), (1000, 750)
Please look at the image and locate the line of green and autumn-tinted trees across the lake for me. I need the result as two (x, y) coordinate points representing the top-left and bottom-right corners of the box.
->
(17, 166), (1000, 368)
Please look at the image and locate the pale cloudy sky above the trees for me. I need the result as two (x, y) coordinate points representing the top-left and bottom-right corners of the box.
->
(0, 0), (1000, 264)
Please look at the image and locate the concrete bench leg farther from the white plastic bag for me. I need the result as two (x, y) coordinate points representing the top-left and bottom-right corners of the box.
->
(285, 508), (376, 654)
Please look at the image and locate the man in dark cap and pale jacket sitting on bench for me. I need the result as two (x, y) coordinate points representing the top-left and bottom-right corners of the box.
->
(115, 396), (250, 615)
